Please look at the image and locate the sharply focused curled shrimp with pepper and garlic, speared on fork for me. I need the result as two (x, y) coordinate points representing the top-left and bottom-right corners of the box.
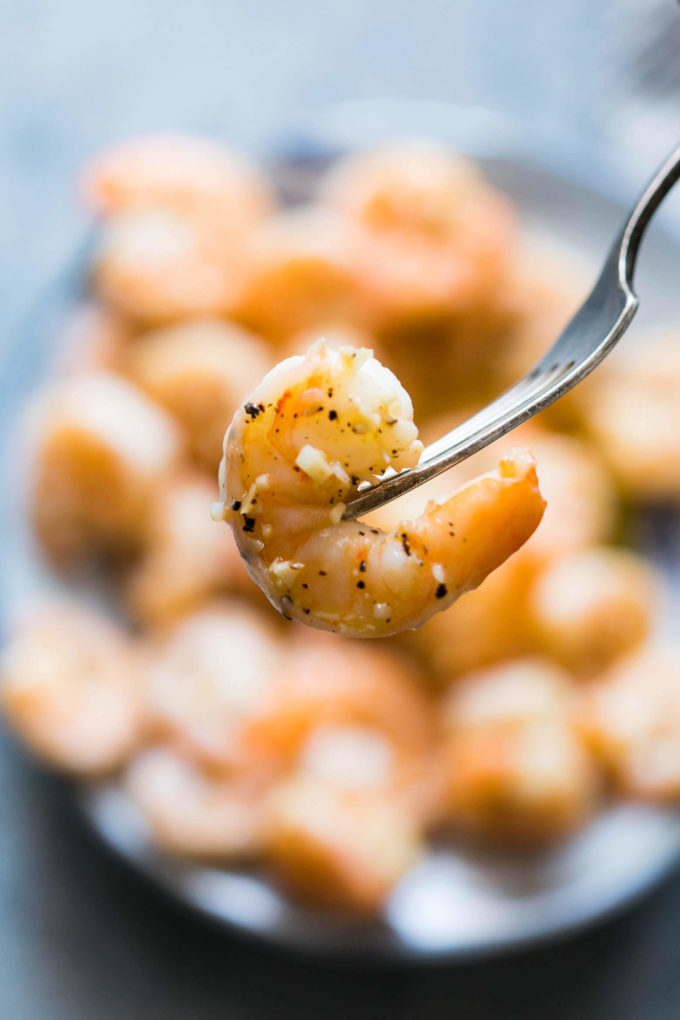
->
(220, 341), (544, 638)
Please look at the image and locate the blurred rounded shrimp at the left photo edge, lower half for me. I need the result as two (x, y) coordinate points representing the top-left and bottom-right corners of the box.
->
(0, 604), (142, 775)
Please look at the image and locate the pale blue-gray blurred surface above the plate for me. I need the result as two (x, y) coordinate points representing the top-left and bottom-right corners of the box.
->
(0, 0), (616, 363)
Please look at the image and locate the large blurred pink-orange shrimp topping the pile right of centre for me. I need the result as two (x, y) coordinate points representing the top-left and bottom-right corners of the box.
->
(319, 142), (516, 323)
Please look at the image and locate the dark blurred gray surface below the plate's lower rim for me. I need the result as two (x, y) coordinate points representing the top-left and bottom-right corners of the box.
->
(0, 745), (680, 1020)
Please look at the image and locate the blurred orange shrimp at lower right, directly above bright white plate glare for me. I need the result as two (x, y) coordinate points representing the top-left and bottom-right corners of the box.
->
(442, 659), (597, 846)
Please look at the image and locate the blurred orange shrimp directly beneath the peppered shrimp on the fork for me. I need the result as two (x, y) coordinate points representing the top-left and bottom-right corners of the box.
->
(247, 631), (436, 818)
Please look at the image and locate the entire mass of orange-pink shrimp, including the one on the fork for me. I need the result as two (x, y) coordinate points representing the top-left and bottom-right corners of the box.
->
(0, 135), (680, 915)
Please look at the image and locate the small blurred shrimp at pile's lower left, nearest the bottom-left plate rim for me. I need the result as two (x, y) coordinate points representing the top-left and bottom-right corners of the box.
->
(124, 746), (269, 861)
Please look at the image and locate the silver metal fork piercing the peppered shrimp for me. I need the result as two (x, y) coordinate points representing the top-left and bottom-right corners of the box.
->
(344, 141), (680, 519)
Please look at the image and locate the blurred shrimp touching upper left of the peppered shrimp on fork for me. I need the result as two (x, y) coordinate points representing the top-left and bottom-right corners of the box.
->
(126, 318), (273, 471)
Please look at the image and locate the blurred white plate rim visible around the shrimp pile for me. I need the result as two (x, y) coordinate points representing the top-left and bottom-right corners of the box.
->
(0, 104), (680, 961)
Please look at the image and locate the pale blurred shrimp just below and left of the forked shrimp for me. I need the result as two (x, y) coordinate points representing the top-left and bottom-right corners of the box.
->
(145, 600), (281, 770)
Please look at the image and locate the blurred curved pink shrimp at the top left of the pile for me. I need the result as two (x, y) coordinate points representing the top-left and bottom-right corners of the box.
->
(82, 133), (273, 226)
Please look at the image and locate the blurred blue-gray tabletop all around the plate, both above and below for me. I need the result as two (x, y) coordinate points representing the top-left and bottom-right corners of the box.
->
(0, 0), (680, 1020)
